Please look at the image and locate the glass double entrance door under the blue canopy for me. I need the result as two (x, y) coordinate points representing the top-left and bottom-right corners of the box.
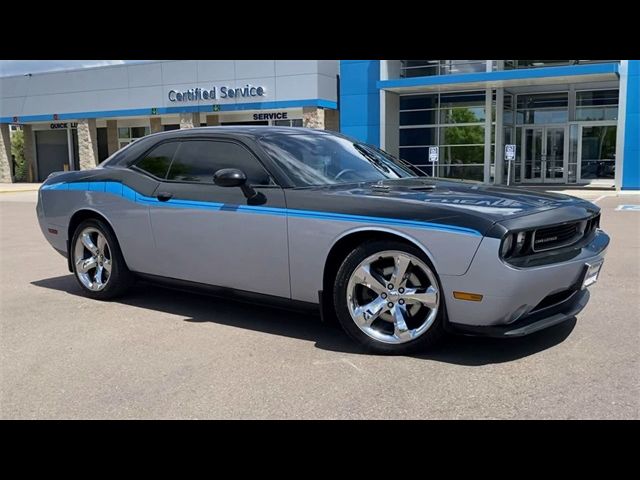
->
(522, 126), (567, 183)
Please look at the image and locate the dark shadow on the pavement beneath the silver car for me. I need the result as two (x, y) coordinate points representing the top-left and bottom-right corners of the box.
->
(31, 275), (576, 366)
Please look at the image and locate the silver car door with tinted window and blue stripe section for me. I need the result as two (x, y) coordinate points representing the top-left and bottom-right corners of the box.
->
(150, 138), (290, 298)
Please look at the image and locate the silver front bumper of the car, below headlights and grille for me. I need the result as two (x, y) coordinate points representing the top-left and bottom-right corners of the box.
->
(441, 230), (609, 337)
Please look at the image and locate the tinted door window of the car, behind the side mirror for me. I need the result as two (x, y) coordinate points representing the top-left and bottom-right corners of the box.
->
(167, 140), (270, 185)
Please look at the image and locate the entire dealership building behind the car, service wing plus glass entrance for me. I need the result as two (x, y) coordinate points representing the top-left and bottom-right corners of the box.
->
(0, 60), (640, 190)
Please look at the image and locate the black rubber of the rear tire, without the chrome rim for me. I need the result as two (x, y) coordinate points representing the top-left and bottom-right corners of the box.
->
(69, 218), (132, 300)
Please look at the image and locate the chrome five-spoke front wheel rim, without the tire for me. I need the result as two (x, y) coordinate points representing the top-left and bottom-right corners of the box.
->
(347, 250), (440, 344)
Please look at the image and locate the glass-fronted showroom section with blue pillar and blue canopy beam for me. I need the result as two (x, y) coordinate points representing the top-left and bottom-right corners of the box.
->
(340, 60), (640, 189)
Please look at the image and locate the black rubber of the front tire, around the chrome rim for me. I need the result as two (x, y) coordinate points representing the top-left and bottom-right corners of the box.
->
(333, 240), (445, 355)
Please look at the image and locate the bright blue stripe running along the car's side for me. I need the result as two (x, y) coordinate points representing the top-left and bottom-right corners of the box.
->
(41, 181), (482, 237)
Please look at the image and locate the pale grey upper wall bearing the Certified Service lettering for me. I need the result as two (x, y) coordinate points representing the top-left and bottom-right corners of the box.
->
(0, 60), (339, 117)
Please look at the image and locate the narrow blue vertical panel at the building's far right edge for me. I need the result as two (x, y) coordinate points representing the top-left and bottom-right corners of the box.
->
(622, 60), (640, 190)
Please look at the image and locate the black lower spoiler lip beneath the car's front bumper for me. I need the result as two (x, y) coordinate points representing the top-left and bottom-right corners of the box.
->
(446, 288), (589, 338)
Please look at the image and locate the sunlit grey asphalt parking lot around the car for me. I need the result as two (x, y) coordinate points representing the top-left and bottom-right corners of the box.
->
(0, 188), (640, 419)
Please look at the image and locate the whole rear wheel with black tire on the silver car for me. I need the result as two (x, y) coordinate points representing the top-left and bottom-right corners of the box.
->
(69, 218), (134, 300)
